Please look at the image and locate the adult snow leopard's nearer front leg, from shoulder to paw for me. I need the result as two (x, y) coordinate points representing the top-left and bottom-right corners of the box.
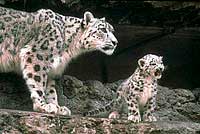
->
(20, 48), (59, 114)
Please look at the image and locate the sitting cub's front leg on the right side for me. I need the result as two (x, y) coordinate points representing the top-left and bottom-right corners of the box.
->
(143, 89), (157, 122)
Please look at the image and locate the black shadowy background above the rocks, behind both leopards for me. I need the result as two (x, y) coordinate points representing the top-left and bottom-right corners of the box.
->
(0, 0), (200, 89)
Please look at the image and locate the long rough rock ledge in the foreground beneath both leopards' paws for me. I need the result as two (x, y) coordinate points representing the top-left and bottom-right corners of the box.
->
(0, 109), (200, 134)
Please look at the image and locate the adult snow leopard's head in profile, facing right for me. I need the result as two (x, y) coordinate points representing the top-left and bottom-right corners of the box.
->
(83, 12), (118, 55)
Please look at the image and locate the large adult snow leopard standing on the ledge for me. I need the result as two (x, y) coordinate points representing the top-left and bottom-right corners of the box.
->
(0, 7), (117, 115)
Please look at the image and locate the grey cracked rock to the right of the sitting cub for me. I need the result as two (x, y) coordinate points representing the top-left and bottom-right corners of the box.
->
(156, 86), (200, 122)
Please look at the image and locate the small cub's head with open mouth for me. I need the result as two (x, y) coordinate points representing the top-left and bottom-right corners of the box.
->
(138, 54), (165, 79)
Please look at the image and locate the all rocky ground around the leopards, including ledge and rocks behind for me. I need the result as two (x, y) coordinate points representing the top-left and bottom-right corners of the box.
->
(0, 74), (200, 134)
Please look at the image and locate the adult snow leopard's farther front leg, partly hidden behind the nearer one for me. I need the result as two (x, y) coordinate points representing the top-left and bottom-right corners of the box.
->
(45, 78), (71, 116)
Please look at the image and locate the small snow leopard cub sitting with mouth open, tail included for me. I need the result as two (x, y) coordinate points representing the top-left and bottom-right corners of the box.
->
(84, 54), (164, 122)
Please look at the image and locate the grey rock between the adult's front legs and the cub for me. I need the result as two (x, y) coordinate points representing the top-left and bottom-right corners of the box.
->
(58, 76), (113, 114)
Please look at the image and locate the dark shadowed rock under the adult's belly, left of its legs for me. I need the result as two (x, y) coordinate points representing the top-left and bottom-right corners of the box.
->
(0, 73), (32, 110)
